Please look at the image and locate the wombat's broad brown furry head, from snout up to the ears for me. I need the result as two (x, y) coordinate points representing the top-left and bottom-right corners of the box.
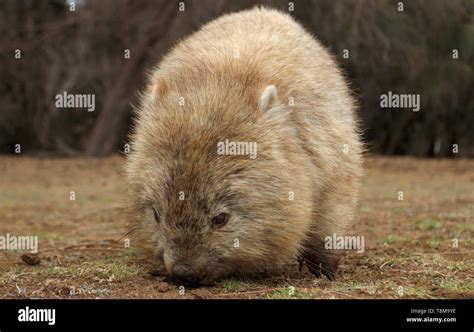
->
(128, 84), (311, 284)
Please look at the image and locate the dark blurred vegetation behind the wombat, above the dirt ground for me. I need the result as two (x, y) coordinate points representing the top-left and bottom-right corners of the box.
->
(0, 0), (474, 157)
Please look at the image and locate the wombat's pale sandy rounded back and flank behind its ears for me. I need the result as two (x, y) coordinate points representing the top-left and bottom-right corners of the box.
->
(150, 8), (362, 170)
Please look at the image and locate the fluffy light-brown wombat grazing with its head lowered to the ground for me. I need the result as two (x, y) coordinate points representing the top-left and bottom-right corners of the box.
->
(126, 8), (363, 284)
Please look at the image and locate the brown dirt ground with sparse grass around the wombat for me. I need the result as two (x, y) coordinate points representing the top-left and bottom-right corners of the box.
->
(0, 156), (474, 299)
